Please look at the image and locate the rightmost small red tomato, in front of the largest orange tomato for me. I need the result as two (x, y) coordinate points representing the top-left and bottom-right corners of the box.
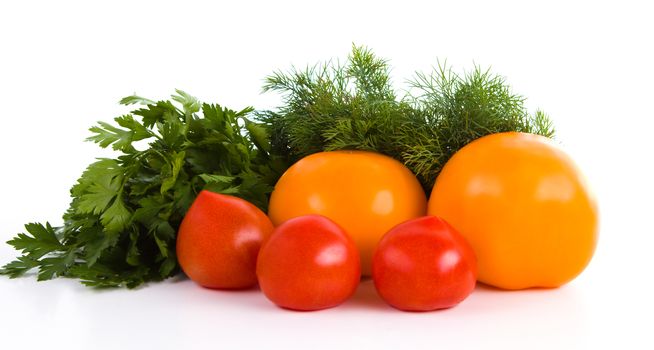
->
(372, 216), (477, 311)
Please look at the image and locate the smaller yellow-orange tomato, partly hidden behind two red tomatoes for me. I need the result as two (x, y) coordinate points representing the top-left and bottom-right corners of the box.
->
(268, 151), (427, 275)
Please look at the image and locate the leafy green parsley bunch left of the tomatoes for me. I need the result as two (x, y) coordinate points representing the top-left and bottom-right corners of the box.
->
(0, 90), (285, 288)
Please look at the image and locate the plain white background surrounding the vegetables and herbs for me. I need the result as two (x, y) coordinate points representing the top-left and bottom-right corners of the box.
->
(0, 0), (654, 349)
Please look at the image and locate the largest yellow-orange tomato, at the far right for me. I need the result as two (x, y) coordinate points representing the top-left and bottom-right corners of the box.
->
(429, 132), (597, 289)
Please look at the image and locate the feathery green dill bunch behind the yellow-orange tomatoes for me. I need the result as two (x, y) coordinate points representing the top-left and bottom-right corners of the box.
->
(259, 46), (554, 193)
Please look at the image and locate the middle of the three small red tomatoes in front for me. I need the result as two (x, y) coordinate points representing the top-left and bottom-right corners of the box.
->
(257, 215), (361, 311)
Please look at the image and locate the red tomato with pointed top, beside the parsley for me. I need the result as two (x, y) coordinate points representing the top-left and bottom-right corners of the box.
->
(177, 191), (273, 289)
